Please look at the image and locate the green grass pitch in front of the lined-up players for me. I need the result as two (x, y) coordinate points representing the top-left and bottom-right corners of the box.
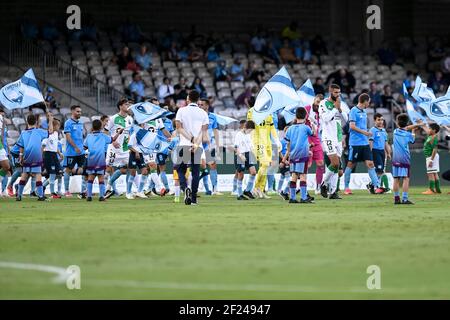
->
(0, 189), (450, 299)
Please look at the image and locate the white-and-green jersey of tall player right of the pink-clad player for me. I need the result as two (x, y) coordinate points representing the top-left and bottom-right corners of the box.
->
(319, 99), (347, 143)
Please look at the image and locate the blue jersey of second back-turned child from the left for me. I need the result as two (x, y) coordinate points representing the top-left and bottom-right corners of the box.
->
(84, 132), (112, 170)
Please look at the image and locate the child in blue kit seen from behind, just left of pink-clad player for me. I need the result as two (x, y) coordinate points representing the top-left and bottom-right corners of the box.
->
(283, 108), (315, 203)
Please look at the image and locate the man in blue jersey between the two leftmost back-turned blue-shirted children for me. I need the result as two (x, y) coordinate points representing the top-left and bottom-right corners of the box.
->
(64, 105), (86, 197)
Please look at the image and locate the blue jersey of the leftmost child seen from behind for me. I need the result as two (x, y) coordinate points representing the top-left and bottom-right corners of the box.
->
(17, 128), (48, 167)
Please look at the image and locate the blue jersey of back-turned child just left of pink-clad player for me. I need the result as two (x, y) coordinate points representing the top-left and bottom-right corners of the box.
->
(285, 123), (312, 163)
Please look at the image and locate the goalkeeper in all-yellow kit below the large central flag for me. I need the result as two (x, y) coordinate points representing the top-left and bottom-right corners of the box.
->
(247, 107), (281, 199)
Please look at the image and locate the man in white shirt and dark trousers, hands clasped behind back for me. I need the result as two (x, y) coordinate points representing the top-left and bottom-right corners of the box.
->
(174, 90), (209, 205)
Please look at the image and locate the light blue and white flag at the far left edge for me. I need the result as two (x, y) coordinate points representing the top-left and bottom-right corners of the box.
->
(0, 69), (44, 110)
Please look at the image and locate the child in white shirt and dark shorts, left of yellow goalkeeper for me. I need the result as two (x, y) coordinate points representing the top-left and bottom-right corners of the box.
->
(234, 120), (256, 200)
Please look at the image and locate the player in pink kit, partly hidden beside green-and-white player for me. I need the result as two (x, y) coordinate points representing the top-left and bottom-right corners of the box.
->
(305, 93), (325, 194)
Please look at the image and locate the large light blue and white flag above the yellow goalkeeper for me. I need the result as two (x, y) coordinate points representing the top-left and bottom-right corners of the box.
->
(252, 66), (300, 124)
